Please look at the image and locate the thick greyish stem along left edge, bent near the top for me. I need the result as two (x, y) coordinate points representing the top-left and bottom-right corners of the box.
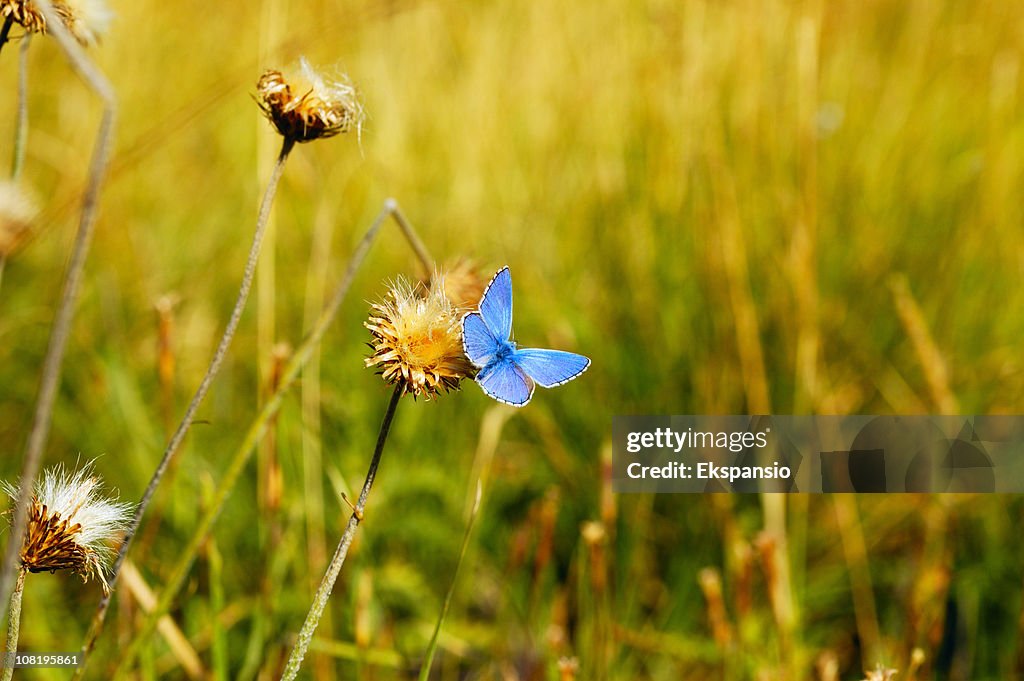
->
(0, 0), (117, 618)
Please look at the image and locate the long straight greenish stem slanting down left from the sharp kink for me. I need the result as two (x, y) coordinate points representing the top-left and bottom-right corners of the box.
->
(91, 200), (419, 679)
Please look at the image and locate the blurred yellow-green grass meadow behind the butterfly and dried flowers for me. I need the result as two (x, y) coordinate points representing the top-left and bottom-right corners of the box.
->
(0, 0), (1024, 680)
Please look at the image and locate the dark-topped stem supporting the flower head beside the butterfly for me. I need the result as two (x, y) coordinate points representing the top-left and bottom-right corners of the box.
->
(281, 383), (404, 681)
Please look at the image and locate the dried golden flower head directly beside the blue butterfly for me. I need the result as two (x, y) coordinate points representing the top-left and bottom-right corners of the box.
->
(364, 279), (473, 399)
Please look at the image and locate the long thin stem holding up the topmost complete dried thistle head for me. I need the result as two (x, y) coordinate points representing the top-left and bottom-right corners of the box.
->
(75, 139), (295, 678)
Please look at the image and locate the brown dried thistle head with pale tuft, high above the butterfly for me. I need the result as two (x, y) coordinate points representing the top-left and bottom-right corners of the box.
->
(256, 57), (365, 142)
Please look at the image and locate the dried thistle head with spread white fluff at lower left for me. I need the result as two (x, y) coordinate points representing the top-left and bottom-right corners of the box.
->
(2, 465), (132, 592)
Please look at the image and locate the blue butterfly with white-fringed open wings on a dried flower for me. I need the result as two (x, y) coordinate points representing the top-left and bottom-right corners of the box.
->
(462, 267), (590, 407)
